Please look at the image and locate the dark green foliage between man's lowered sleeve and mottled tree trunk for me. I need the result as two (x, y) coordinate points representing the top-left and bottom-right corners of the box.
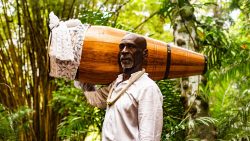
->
(157, 80), (186, 141)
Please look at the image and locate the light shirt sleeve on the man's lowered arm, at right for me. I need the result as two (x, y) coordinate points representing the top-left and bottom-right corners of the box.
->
(138, 86), (163, 141)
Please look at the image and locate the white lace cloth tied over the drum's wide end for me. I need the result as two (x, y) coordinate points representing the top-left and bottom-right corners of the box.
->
(49, 12), (89, 80)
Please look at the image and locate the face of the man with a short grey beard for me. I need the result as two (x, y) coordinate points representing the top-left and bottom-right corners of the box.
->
(119, 35), (145, 69)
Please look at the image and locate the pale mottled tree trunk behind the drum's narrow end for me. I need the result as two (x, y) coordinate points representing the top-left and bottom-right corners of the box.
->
(173, 2), (216, 141)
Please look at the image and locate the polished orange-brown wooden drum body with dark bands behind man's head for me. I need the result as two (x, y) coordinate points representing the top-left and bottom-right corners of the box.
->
(78, 26), (206, 84)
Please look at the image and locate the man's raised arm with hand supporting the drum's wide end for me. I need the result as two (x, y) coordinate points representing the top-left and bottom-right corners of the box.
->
(75, 82), (111, 108)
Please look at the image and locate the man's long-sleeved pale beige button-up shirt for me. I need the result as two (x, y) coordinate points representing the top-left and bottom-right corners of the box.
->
(85, 70), (163, 141)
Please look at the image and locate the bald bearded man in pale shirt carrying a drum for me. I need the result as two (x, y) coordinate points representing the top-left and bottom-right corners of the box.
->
(79, 34), (163, 141)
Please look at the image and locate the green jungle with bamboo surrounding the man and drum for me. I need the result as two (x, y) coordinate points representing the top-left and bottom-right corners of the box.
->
(0, 0), (250, 141)
